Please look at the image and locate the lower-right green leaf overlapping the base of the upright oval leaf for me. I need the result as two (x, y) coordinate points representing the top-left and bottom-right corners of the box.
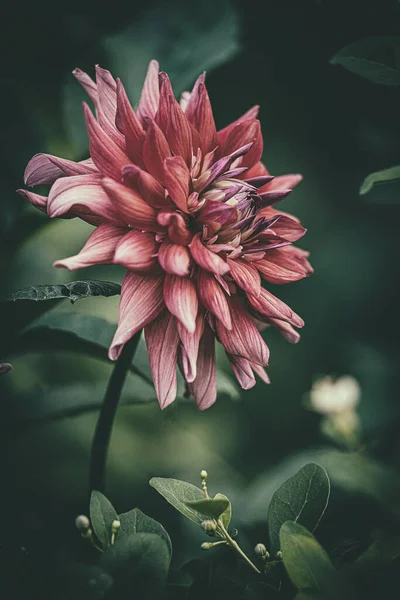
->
(279, 521), (335, 592)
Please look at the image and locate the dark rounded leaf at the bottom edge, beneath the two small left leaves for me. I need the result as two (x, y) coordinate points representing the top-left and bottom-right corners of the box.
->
(99, 533), (170, 600)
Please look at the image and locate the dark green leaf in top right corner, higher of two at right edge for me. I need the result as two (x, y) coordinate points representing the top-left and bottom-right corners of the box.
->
(331, 36), (400, 85)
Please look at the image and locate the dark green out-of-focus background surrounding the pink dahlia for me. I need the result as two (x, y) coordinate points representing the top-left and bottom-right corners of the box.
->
(0, 0), (400, 597)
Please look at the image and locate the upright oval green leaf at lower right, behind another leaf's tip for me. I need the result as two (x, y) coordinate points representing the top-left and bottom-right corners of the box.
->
(268, 463), (330, 552)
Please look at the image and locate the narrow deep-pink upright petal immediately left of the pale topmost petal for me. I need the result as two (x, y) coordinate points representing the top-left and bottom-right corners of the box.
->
(115, 79), (145, 166)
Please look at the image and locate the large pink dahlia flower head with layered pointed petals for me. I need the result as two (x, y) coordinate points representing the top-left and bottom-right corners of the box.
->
(21, 61), (312, 410)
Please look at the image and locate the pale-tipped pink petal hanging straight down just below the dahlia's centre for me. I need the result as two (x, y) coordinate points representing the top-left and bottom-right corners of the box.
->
(164, 273), (199, 333)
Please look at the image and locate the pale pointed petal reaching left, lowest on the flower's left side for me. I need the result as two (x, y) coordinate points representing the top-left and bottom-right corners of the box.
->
(53, 223), (126, 271)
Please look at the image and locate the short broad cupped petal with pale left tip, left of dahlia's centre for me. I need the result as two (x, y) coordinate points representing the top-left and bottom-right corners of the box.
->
(114, 230), (158, 272)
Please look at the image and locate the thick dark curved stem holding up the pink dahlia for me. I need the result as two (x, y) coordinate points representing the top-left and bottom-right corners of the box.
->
(89, 331), (141, 493)
